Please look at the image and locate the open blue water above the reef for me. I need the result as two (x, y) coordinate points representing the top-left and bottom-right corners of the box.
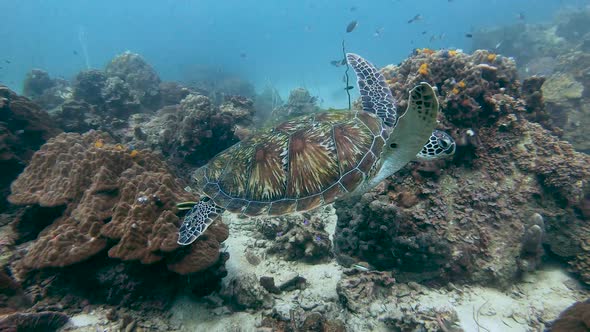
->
(0, 0), (588, 107)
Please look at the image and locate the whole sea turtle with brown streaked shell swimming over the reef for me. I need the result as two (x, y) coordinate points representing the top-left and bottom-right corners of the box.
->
(178, 53), (455, 245)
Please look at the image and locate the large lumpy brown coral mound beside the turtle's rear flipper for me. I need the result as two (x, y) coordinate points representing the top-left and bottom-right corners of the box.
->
(9, 131), (227, 274)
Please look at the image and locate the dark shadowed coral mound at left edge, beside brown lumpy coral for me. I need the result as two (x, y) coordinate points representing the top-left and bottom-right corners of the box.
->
(0, 85), (60, 211)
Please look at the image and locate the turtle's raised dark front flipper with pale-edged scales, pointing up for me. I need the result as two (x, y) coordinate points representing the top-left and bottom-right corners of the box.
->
(346, 53), (398, 127)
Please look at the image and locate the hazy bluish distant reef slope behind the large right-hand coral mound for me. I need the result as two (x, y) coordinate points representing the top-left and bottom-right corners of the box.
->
(474, 8), (590, 153)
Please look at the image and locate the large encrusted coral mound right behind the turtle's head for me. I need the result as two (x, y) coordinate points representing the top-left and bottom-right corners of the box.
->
(335, 50), (590, 287)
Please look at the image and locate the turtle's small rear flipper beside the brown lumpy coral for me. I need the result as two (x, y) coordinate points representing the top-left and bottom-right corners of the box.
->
(177, 197), (224, 245)
